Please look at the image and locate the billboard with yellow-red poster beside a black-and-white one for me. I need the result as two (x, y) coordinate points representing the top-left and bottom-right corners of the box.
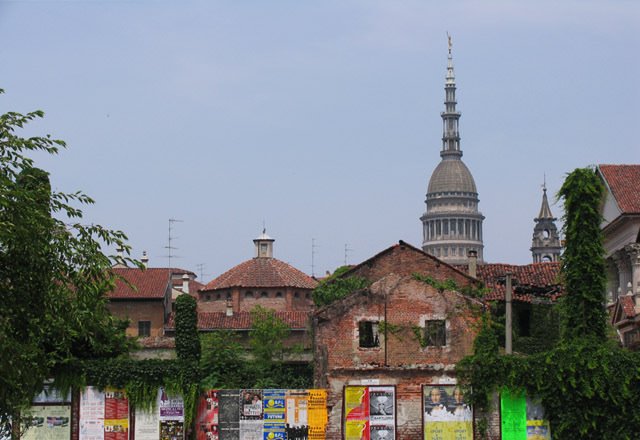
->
(343, 386), (396, 440)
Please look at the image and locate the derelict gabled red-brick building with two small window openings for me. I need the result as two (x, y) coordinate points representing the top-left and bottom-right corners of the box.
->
(314, 241), (483, 440)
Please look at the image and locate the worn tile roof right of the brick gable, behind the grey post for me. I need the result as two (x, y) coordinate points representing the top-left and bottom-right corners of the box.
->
(458, 262), (563, 302)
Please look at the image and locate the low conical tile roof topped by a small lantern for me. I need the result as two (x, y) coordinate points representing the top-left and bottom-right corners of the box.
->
(201, 258), (318, 291)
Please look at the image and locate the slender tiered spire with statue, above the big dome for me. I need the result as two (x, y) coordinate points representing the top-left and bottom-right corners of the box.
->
(440, 33), (462, 159)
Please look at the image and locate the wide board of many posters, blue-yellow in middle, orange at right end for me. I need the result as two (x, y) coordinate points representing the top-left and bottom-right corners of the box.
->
(196, 389), (327, 440)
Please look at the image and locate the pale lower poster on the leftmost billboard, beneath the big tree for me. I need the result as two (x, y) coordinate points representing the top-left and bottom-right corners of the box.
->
(21, 405), (71, 440)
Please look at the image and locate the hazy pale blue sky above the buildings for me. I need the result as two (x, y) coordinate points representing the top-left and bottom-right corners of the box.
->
(0, 0), (640, 282)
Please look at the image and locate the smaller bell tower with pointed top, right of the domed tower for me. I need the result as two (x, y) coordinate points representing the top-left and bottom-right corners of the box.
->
(531, 185), (562, 263)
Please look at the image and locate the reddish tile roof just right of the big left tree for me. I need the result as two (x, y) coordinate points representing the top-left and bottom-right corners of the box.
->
(108, 267), (192, 299)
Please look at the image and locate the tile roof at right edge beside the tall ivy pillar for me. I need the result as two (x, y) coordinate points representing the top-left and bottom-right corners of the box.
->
(598, 165), (640, 214)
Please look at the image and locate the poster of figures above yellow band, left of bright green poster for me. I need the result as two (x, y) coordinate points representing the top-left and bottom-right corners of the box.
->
(422, 385), (473, 440)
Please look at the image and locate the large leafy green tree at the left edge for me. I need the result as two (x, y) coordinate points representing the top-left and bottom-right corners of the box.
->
(0, 90), (131, 432)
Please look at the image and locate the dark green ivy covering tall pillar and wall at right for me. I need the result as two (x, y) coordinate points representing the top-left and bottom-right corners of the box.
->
(456, 169), (640, 440)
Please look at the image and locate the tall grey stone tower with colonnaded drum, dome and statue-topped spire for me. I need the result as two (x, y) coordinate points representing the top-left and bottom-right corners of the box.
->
(420, 37), (484, 264)
